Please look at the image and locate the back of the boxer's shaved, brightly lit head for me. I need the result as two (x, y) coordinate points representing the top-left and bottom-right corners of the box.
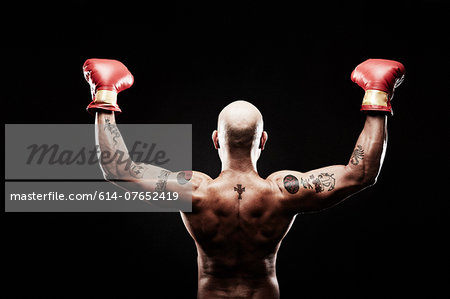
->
(217, 101), (263, 150)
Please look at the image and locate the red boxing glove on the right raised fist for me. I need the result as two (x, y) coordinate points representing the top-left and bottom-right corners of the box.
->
(351, 59), (405, 114)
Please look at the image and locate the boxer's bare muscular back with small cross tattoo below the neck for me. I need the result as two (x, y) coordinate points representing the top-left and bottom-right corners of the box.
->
(182, 170), (294, 298)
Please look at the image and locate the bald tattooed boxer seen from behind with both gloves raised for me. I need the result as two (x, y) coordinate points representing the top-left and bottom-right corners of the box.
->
(83, 59), (405, 299)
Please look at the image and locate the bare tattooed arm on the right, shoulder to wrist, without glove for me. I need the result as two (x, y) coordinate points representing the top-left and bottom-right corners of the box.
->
(273, 114), (387, 213)
